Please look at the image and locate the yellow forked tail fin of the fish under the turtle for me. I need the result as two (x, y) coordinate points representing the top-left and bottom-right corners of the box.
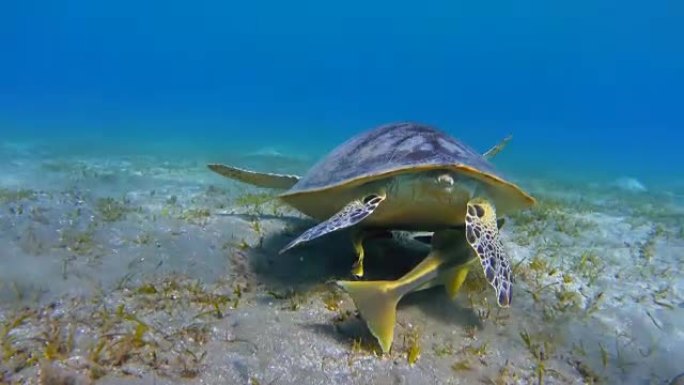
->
(337, 281), (402, 353)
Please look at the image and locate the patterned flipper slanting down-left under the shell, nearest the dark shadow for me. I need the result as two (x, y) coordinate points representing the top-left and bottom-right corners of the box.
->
(280, 194), (386, 254)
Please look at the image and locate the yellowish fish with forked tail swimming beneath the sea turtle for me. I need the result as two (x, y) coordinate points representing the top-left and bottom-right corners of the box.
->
(337, 219), (504, 353)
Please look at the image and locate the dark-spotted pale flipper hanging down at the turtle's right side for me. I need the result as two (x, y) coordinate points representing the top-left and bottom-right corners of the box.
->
(465, 198), (513, 307)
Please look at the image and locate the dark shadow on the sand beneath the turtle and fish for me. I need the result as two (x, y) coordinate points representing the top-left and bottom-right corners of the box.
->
(240, 218), (482, 342)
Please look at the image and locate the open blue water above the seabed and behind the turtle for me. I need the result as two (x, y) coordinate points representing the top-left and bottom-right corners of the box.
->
(0, 0), (684, 179)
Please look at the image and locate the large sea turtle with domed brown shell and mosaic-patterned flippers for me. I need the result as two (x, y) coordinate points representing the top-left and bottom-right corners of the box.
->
(209, 122), (535, 307)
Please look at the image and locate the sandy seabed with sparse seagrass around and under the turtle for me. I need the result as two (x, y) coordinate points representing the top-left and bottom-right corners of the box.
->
(0, 145), (684, 385)
